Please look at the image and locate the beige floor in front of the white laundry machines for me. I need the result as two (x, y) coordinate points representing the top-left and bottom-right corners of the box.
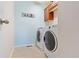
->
(12, 46), (46, 58)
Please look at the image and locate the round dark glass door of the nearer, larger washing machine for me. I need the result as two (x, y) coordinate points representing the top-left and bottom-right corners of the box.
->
(44, 31), (57, 51)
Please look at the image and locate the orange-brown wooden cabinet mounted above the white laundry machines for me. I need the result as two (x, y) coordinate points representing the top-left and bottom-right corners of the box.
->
(44, 2), (57, 21)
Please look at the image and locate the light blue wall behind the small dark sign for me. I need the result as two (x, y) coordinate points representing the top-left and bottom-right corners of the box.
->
(15, 1), (45, 46)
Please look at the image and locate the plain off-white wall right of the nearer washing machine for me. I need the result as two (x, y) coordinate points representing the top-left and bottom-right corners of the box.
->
(51, 1), (79, 57)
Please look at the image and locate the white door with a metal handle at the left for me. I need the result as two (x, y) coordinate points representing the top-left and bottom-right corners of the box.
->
(0, 2), (14, 58)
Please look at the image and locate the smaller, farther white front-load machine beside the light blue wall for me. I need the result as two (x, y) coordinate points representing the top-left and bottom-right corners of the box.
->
(36, 27), (44, 50)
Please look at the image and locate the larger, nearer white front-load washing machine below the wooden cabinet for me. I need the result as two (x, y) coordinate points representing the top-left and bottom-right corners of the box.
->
(42, 25), (58, 57)
